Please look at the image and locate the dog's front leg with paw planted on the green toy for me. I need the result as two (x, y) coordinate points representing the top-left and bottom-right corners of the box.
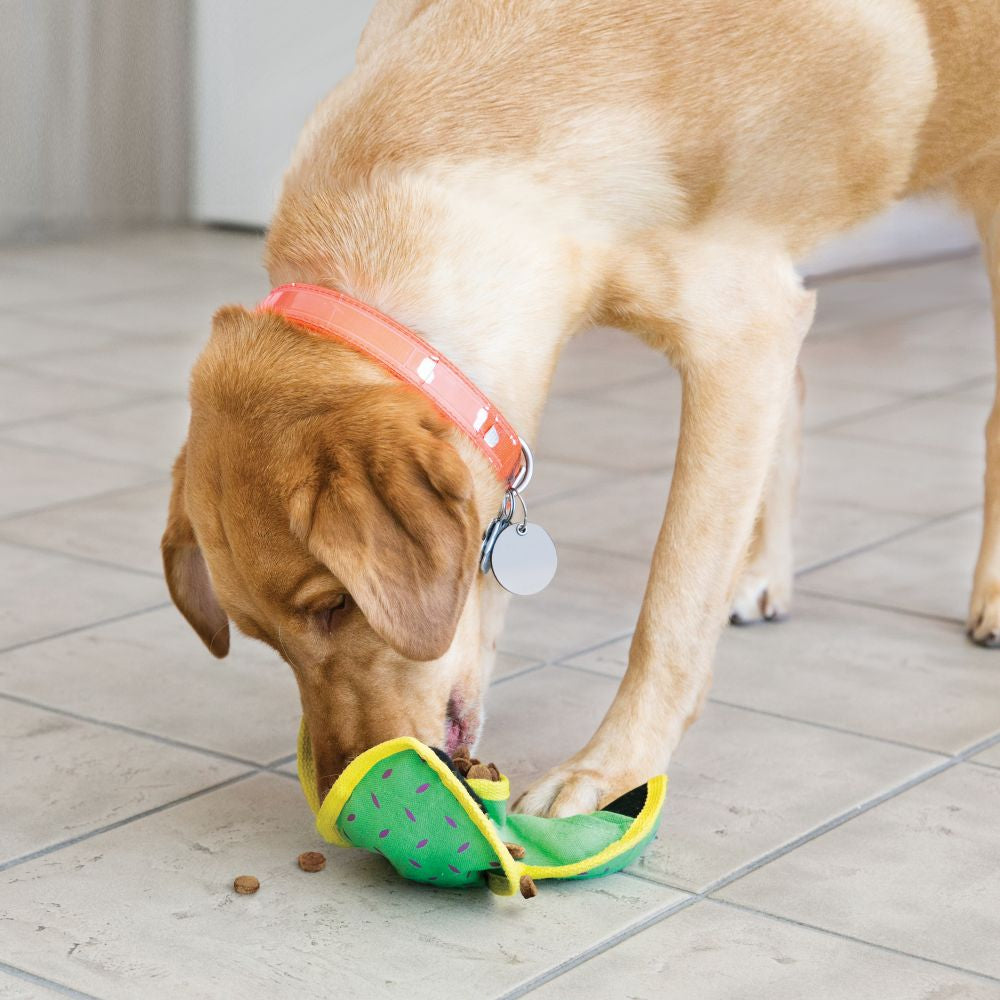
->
(517, 254), (815, 816)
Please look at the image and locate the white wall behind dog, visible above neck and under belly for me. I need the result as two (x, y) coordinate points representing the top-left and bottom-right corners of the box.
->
(193, 0), (976, 274)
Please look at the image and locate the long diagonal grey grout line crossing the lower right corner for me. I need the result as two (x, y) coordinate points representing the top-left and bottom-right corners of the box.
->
(508, 733), (1000, 1000)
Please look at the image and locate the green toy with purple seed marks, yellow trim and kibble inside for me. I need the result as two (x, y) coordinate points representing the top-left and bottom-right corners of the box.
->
(298, 722), (667, 896)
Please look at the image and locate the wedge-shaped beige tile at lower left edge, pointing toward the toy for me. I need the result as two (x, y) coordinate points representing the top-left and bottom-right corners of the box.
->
(0, 699), (245, 868)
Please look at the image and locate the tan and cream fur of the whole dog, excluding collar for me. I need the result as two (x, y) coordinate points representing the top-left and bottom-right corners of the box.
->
(163, 0), (1000, 815)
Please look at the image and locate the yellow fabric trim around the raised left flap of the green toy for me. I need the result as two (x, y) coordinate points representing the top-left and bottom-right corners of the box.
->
(299, 721), (524, 896)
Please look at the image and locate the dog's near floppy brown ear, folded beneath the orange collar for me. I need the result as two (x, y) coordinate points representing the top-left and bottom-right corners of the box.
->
(289, 388), (479, 660)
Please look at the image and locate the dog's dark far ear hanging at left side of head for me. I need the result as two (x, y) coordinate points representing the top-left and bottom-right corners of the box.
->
(160, 445), (229, 659)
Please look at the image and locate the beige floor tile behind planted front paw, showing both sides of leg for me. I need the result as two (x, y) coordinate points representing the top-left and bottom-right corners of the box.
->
(479, 667), (940, 890)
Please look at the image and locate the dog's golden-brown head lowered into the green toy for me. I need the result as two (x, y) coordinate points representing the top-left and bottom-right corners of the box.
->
(162, 308), (482, 796)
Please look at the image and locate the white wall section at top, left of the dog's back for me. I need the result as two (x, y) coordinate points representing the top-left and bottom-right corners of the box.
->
(192, 0), (375, 226)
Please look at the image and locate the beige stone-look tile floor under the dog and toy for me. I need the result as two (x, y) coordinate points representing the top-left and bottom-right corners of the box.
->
(0, 229), (1000, 1000)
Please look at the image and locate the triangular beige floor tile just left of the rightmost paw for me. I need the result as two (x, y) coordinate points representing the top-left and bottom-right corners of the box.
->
(799, 511), (984, 620)
